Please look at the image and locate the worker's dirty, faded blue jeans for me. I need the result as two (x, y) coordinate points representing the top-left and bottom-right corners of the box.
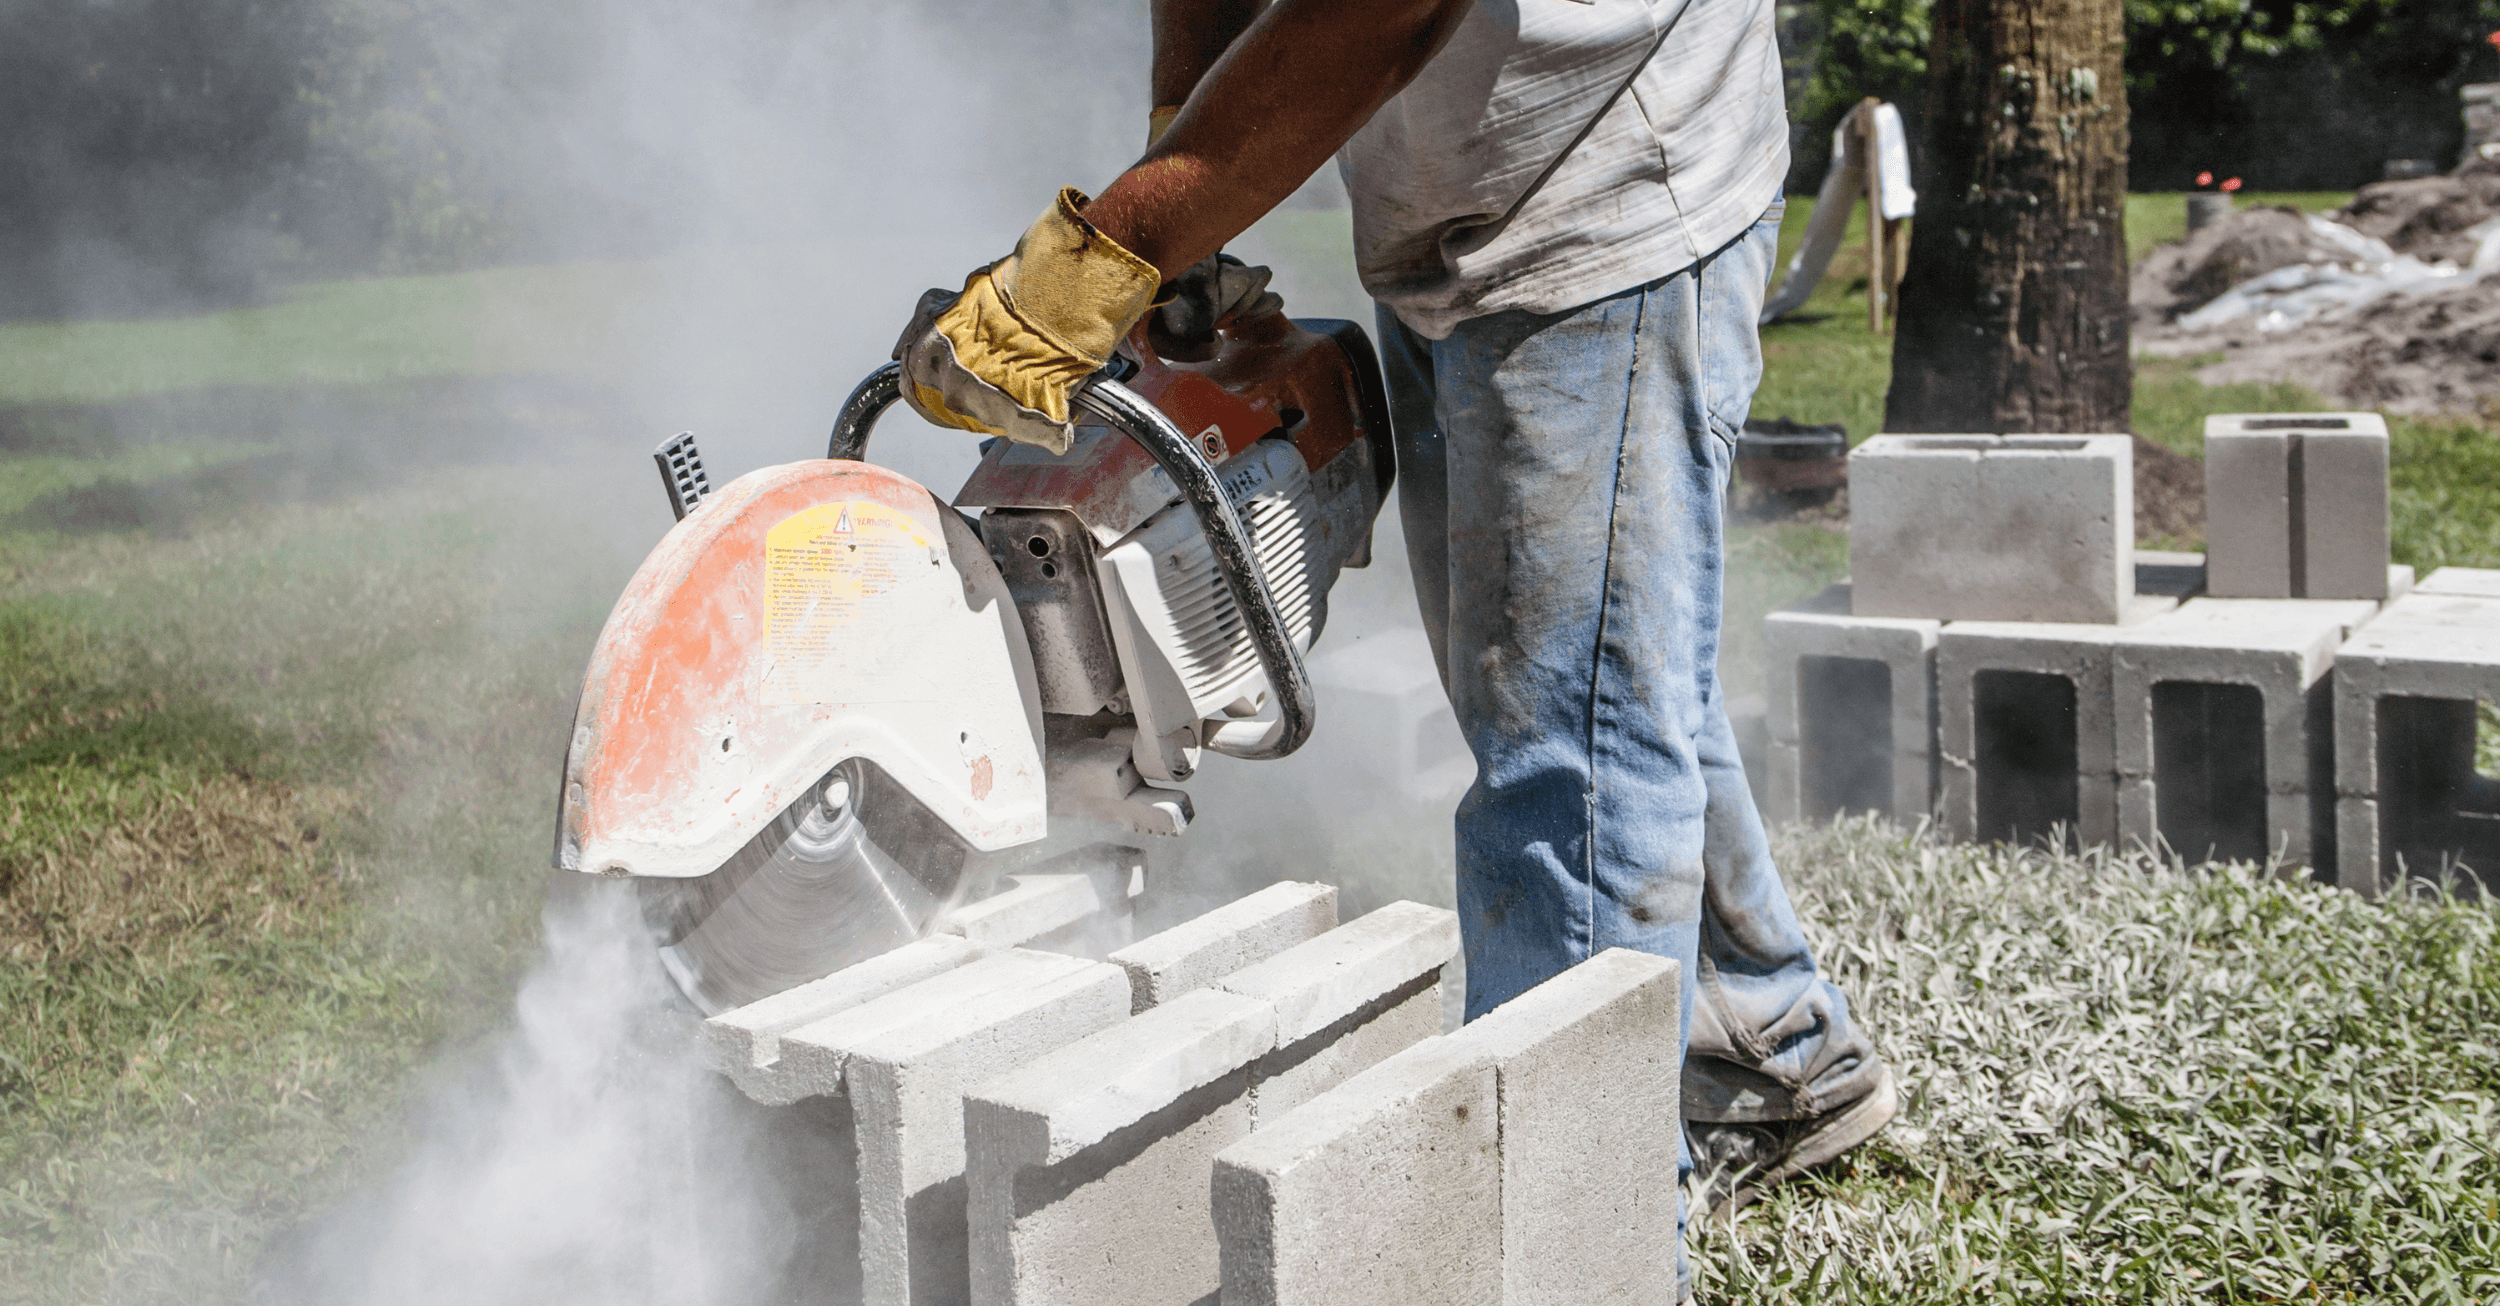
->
(1380, 205), (1880, 1260)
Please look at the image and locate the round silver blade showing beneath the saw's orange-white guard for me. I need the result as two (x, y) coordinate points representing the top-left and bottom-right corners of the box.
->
(643, 761), (945, 1016)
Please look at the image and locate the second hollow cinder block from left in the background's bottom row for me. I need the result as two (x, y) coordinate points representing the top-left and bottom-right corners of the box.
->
(1935, 620), (2130, 843)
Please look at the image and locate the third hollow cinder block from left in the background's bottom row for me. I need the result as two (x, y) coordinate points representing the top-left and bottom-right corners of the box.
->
(2110, 598), (2378, 866)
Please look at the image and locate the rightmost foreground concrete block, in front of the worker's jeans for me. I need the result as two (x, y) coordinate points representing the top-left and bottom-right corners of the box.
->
(1215, 951), (1680, 1306)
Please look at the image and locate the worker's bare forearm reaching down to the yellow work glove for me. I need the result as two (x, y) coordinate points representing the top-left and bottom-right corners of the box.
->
(1105, 0), (1473, 278)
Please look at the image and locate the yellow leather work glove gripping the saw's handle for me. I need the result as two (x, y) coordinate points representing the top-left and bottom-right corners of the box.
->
(895, 188), (1163, 453)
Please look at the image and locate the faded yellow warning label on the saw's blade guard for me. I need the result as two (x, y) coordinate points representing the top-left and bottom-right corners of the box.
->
(765, 500), (938, 703)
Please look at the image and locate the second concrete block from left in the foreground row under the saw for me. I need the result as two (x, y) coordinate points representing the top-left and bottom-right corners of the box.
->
(783, 948), (1128, 1306)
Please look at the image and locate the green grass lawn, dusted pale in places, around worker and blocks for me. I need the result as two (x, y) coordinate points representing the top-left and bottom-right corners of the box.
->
(0, 195), (2500, 1303)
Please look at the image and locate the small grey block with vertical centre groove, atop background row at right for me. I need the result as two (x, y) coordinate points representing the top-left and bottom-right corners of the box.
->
(2205, 413), (2390, 598)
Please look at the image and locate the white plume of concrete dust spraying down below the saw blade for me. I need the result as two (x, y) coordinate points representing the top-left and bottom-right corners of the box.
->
(258, 883), (853, 1306)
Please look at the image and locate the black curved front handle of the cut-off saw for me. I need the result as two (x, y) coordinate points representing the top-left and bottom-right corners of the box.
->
(825, 363), (1318, 761)
